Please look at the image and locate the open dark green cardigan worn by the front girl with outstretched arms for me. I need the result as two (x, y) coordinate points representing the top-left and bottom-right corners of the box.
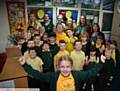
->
(23, 63), (103, 91)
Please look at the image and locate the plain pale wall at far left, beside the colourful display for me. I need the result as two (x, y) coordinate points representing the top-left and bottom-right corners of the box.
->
(0, 0), (9, 53)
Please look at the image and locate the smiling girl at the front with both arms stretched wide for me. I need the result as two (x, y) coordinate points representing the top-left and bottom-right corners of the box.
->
(19, 56), (105, 91)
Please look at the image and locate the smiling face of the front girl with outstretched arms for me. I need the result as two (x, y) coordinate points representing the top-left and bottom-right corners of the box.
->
(59, 60), (72, 77)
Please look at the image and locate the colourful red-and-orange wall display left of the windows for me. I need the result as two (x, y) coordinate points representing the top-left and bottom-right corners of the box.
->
(6, 1), (26, 36)
